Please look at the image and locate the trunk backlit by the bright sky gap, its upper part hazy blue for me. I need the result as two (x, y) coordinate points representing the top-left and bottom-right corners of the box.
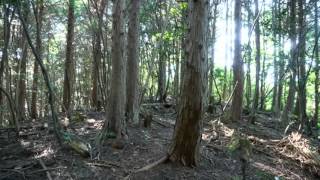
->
(231, 1), (243, 121)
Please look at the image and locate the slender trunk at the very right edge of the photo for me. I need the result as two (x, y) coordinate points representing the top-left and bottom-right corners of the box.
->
(312, 1), (320, 127)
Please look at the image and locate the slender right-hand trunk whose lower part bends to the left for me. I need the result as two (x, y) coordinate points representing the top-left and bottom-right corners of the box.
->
(281, 0), (297, 125)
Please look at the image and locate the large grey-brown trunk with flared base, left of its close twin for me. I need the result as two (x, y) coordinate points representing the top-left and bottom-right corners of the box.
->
(100, 0), (126, 139)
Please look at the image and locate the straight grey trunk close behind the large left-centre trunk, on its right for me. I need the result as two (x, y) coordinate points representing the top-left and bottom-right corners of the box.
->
(126, 0), (140, 123)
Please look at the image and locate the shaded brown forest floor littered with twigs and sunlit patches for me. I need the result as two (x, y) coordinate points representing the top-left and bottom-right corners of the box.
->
(0, 104), (320, 180)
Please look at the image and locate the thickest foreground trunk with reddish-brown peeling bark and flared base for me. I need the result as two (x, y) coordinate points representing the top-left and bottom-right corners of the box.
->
(169, 0), (208, 166)
